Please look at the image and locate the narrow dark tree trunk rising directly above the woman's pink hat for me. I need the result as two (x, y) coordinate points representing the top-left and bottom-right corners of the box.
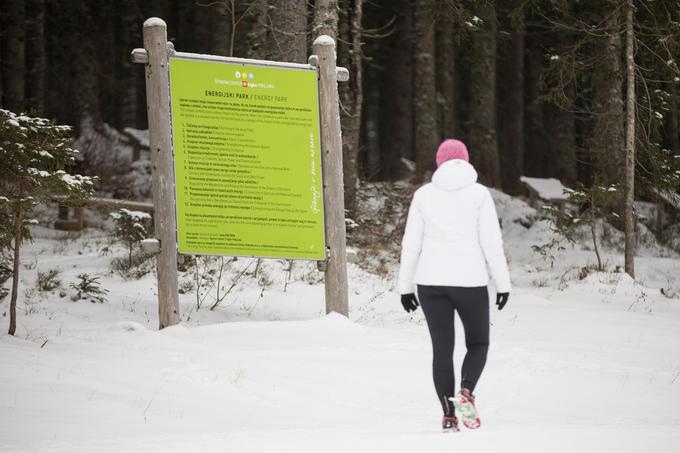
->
(435, 2), (456, 142)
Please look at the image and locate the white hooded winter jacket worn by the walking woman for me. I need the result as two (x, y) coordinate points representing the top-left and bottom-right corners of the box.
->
(399, 159), (510, 294)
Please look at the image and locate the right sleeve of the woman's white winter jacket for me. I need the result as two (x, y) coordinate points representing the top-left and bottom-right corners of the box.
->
(478, 190), (511, 293)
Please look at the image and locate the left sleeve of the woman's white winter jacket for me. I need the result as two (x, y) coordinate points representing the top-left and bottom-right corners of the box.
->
(399, 193), (424, 294)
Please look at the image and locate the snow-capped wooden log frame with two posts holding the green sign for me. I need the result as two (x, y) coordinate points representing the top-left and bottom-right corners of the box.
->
(132, 18), (349, 329)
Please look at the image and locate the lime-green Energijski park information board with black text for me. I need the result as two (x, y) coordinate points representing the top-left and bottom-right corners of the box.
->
(170, 58), (325, 260)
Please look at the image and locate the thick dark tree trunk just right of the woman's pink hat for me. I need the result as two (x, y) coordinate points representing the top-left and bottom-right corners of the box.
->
(467, 0), (501, 187)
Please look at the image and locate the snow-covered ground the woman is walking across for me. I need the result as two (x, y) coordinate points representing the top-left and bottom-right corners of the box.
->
(0, 193), (680, 453)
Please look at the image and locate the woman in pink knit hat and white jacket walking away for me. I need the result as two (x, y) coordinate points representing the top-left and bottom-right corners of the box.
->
(399, 139), (510, 431)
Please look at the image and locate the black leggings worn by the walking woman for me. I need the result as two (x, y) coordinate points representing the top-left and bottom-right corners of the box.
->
(418, 285), (489, 414)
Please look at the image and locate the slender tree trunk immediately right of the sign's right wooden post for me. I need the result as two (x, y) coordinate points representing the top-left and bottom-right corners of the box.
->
(338, 0), (364, 216)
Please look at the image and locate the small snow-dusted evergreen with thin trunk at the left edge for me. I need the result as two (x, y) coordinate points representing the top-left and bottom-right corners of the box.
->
(0, 109), (94, 335)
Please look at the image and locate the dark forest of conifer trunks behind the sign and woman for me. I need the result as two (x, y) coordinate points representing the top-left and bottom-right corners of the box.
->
(0, 0), (680, 224)
